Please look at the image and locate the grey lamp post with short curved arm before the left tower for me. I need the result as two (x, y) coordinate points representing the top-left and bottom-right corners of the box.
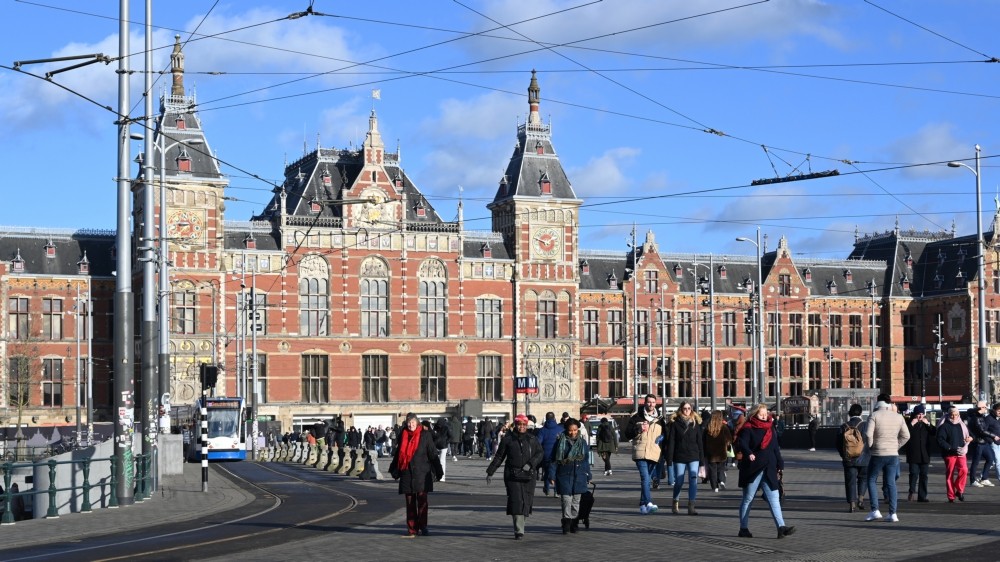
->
(157, 136), (202, 432)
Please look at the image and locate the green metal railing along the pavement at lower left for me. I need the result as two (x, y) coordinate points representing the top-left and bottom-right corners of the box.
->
(0, 448), (152, 525)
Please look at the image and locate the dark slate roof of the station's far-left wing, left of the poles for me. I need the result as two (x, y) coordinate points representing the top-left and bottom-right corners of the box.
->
(0, 227), (115, 277)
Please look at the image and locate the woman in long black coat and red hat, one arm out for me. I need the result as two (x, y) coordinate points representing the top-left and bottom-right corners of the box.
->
(486, 414), (542, 540)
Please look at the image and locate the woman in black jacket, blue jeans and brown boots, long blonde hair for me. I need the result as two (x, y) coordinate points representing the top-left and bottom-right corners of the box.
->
(664, 402), (705, 515)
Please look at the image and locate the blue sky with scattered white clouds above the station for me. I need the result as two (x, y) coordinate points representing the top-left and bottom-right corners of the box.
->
(0, 0), (1000, 258)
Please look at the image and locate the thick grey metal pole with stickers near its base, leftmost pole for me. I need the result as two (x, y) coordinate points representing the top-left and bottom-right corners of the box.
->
(112, 0), (135, 506)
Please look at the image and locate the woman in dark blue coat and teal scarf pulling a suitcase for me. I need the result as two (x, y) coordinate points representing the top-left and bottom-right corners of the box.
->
(552, 418), (593, 535)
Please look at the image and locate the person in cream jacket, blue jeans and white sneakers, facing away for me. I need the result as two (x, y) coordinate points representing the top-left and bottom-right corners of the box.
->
(865, 394), (910, 523)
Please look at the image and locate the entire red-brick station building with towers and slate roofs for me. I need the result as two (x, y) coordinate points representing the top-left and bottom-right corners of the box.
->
(0, 41), (1000, 431)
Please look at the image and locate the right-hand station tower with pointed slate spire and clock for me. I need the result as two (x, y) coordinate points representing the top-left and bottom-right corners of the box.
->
(488, 71), (583, 411)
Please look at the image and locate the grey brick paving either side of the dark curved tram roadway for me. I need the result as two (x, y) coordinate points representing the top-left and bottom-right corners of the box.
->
(0, 444), (1000, 561)
